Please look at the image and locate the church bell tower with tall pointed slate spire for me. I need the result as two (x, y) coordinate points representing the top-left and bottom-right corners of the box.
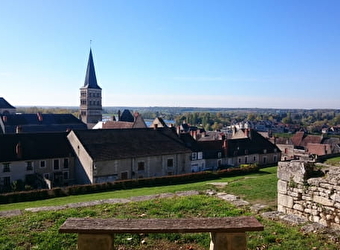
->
(80, 49), (102, 128)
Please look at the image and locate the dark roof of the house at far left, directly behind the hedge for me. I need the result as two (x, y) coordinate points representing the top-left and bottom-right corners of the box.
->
(0, 132), (73, 162)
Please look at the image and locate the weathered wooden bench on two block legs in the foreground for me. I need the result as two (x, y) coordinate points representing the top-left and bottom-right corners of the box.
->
(59, 217), (263, 250)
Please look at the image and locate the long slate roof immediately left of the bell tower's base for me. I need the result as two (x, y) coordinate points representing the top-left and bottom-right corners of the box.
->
(0, 114), (87, 134)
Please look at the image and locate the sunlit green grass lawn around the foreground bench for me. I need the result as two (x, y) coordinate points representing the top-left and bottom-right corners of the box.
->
(0, 167), (339, 250)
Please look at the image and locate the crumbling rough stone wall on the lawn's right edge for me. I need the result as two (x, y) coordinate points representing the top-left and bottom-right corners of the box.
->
(277, 161), (340, 229)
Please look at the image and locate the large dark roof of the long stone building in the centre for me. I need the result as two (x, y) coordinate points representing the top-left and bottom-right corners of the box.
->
(73, 128), (191, 161)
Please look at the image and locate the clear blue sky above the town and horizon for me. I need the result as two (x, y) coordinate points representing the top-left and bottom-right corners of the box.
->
(0, 0), (340, 109)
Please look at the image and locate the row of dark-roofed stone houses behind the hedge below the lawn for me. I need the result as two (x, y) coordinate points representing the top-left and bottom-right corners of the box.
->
(0, 125), (281, 191)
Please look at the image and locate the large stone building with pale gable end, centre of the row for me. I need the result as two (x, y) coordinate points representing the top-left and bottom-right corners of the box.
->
(67, 128), (191, 184)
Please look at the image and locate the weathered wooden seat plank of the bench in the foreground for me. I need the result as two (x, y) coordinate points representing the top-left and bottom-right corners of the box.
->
(59, 216), (263, 234)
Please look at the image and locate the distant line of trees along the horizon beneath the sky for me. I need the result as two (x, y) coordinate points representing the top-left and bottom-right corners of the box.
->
(17, 107), (340, 133)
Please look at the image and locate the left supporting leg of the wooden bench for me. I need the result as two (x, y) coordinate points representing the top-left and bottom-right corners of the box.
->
(78, 234), (113, 250)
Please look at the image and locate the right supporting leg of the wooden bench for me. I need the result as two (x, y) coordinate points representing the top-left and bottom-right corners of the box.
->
(210, 233), (247, 250)
